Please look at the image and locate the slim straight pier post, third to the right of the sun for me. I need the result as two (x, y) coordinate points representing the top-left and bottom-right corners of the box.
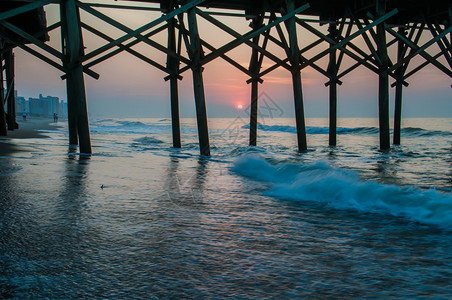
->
(328, 23), (338, 146)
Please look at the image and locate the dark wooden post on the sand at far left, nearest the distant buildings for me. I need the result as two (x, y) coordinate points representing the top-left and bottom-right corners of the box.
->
(4, 49), (19, 131)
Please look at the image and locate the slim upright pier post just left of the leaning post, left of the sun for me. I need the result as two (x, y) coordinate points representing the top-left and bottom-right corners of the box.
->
(167, 12), (181, 148)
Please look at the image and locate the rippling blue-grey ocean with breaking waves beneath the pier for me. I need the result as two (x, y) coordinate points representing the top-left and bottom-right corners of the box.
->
(0, 115), (452, 299)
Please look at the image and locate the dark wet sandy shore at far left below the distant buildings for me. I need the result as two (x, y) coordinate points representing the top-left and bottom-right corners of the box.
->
(0, 118), (58, 156)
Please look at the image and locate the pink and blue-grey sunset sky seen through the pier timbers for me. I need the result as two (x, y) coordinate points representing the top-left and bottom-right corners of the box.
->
(15, 5), (452, 118)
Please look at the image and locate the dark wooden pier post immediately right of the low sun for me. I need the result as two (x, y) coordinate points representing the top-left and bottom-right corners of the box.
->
(249, 16), (263, 146)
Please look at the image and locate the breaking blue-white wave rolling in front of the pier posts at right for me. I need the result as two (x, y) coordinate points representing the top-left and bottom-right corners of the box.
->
(233, 154), (452, 230)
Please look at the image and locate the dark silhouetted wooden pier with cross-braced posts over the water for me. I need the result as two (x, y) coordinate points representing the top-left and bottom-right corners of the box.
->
(0, 0), (452, 155)
